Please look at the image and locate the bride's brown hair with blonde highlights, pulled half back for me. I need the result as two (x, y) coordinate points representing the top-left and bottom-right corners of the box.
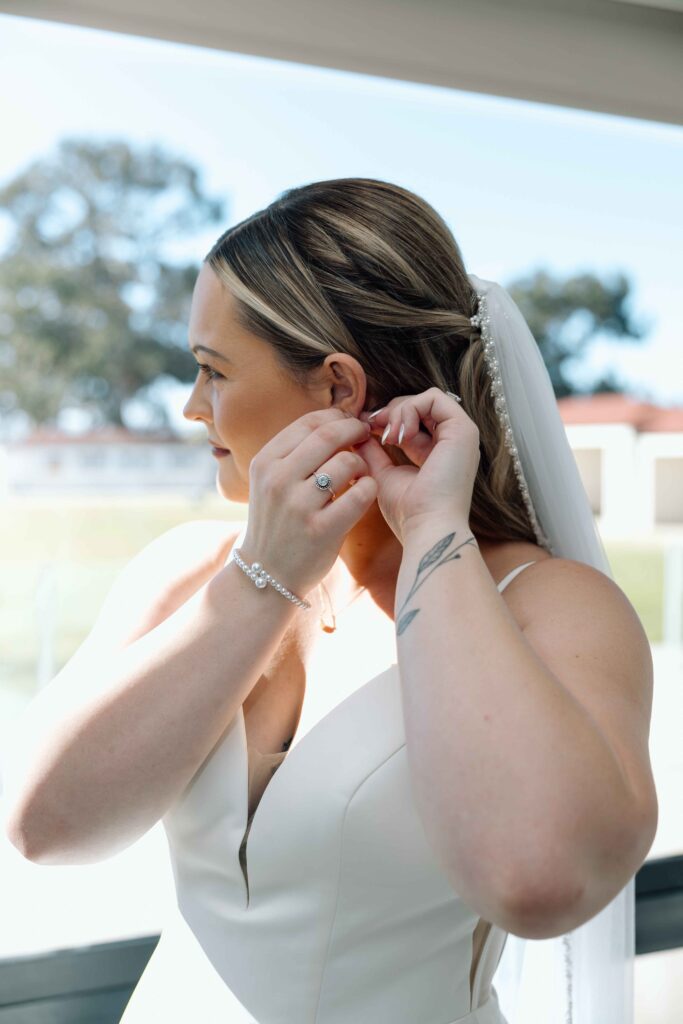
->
(204, 178), (537, 544)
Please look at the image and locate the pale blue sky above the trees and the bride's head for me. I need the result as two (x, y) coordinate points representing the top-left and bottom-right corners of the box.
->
(0, 15), (683, 432)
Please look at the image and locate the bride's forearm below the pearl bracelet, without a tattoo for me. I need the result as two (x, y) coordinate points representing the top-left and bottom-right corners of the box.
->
(8, 564), (302, 864)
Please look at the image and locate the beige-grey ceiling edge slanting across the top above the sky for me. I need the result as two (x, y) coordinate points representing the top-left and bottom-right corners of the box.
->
(5, 0), (683, 125)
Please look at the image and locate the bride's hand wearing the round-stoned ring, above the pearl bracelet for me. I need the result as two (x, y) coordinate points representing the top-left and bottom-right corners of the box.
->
(240, 408), (378, 598)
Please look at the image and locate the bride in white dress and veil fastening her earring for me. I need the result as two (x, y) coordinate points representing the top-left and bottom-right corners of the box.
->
(3, 178), (656, 1024)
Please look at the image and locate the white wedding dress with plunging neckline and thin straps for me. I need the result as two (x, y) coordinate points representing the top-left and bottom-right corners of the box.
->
(121, 525), (532, 1024)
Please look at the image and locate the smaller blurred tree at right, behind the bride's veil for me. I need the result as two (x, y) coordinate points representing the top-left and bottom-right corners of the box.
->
(505, 270), (646, 398)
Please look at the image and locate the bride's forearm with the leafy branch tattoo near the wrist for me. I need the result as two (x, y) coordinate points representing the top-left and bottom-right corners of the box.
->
(395, 519), (629, 925)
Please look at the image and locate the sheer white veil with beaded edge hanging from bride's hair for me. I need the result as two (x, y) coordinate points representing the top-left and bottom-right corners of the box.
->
(468, 274), (635, 1024)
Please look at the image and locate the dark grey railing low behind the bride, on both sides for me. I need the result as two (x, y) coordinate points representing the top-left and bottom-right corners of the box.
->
(0, 855), (683, 1024)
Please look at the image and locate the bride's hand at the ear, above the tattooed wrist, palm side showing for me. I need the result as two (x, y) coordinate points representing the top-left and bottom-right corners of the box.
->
(354, 387), (480, 544)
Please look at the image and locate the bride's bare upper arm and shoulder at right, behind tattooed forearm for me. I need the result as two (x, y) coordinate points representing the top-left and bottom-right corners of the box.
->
(522, 558), (657, 842)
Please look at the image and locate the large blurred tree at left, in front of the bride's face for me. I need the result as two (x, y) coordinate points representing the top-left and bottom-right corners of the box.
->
(0, 138), (224, 428)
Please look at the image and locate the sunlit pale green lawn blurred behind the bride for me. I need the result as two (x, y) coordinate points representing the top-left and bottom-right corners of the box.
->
(0, 495), (664, 696)
